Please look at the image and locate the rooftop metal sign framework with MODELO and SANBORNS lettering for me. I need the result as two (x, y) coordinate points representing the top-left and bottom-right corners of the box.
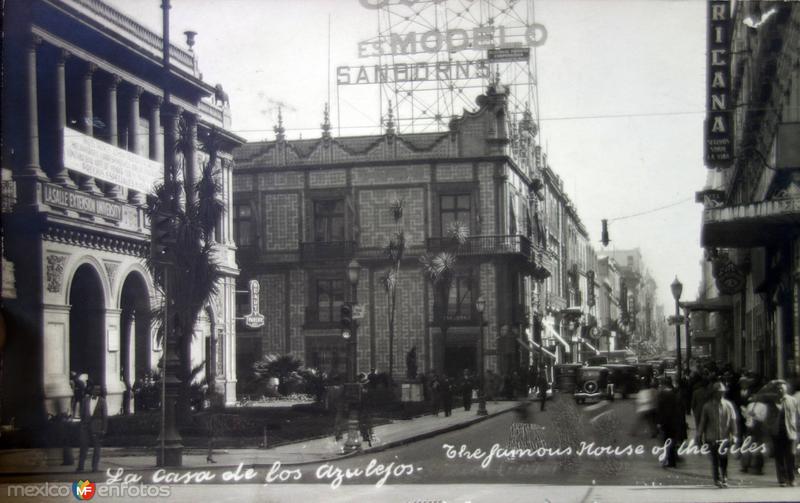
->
(336, 0), (547, 133)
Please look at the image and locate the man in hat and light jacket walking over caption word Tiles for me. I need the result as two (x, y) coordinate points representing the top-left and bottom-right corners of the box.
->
(695, 381), (738, 487)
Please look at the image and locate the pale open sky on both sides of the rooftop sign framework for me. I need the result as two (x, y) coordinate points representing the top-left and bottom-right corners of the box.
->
(106, 0), (706, 311)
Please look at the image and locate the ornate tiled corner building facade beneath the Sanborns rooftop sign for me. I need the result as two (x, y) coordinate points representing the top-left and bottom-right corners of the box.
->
(234, 84), (546, 378)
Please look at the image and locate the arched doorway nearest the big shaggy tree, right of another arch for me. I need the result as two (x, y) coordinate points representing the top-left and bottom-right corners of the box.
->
(120, 272), (152, 414)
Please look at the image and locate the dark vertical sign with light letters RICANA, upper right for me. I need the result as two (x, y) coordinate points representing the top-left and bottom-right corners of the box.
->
(705, 0), (733, 168)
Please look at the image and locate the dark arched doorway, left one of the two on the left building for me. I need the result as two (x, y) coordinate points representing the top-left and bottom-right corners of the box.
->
(69, 264), (106, 385)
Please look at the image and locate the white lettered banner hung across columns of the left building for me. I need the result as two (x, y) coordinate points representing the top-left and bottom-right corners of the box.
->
(62, 128), (164, 194)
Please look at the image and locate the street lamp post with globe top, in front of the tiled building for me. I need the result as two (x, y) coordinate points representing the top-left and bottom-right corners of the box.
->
(342, 259), (361, 452)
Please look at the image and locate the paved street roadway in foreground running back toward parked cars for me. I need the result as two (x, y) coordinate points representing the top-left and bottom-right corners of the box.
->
(0, 400), (800, 503)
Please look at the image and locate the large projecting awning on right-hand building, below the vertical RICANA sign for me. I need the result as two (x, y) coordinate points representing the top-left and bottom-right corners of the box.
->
(700, 195), (800, 248)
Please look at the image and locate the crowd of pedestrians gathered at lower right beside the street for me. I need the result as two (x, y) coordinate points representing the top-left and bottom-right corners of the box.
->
(636, 364), (800, 487)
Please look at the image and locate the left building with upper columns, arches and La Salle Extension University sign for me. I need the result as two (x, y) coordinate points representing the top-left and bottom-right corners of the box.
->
(0, 0), (242, 424)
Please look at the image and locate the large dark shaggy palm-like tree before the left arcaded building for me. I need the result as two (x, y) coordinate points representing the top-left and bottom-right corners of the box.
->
(146, 127), (225, 418)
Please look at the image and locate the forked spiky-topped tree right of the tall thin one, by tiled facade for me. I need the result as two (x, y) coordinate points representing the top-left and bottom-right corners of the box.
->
(420, 222), (469, 374)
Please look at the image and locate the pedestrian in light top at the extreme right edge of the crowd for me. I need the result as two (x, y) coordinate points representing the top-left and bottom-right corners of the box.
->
(767, 380), (800, 487)
